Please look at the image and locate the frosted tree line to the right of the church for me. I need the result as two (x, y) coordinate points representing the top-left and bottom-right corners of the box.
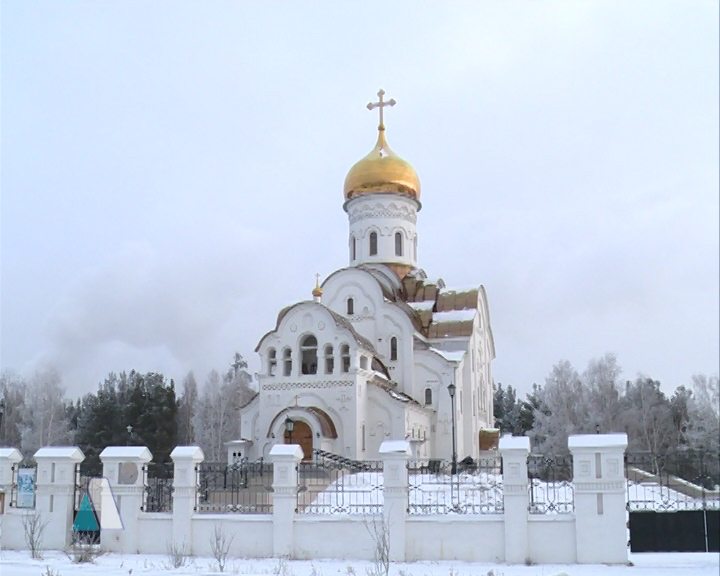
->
(493, 354), (720, 456)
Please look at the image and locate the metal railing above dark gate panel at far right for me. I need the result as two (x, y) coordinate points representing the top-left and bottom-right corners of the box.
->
(625, 450), (720, 512)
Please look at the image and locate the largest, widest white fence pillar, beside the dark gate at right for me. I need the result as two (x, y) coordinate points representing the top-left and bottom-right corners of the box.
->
(568, 434), (629, 564)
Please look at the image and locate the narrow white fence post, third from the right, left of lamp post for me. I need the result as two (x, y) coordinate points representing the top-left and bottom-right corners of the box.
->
(376, 440), (412, 562)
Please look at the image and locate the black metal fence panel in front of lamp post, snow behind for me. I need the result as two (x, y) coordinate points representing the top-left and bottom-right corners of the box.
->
(408, 456), (504, 515)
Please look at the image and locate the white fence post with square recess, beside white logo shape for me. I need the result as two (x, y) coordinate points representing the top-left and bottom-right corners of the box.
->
(100, 446), (152, 554)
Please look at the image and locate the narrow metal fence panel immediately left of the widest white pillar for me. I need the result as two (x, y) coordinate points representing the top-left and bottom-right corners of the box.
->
(527, 454), (575, 514)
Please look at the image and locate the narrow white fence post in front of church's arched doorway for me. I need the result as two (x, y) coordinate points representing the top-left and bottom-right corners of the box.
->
(270, 444), (303, 558)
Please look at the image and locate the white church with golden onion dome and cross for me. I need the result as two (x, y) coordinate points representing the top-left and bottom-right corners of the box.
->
(236, 90), (497, 460)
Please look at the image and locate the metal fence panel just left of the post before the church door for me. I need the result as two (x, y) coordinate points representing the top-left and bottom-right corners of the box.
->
(195, 458), (273, 514)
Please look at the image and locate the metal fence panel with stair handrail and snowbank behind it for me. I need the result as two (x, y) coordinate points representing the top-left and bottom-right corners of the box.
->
(296, 451), (383, 514)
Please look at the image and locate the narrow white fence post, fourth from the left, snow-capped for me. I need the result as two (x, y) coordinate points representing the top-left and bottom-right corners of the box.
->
(170, 446), (205, 554)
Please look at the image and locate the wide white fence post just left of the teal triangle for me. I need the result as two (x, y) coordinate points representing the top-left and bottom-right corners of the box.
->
(35, 446), (85, 550)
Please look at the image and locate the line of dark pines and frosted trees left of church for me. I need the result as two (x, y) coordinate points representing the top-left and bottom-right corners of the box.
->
(0, 354), (255, 476)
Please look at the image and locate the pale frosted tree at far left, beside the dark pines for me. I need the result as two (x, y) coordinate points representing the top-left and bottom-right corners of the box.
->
(20, 368), (73, 456)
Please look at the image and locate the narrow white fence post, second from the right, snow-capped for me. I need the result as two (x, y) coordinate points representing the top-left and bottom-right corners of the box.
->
(499, 436), (530, 564)
